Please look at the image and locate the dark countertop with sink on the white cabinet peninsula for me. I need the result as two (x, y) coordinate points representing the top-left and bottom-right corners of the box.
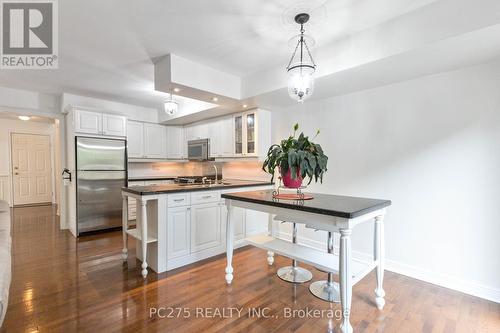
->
(122, 179), (273, 195)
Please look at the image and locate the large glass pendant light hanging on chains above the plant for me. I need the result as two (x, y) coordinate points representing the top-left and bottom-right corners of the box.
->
(286, 13), (316, 102)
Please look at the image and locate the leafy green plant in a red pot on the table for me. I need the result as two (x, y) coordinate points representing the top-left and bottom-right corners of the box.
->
(262, 124), (328, 188)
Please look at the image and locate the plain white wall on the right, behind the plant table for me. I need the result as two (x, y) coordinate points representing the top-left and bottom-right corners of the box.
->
(273, 61), (500, 302)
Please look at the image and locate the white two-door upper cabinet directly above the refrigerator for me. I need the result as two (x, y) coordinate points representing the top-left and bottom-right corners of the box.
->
(74, 110), (127, 137)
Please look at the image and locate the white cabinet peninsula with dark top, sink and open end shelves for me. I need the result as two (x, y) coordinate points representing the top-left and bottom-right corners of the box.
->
(122, 179), (273, 277)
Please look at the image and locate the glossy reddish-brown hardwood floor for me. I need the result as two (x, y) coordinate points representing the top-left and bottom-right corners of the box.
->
(0, 206), (500, 333)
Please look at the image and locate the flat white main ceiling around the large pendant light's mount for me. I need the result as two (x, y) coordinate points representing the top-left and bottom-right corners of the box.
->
(0, 0), (500, 122)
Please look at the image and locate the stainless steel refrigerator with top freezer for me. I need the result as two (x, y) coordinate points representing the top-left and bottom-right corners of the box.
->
(75, 137), (127, 235)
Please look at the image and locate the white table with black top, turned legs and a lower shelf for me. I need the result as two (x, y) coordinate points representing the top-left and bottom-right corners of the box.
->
(222, 190), (391, 333)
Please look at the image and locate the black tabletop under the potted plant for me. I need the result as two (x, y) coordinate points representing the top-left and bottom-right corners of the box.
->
(222, 190), (391, 219)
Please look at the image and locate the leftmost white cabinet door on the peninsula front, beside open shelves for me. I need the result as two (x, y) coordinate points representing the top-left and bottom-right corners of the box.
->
(167, 206), (191, 259)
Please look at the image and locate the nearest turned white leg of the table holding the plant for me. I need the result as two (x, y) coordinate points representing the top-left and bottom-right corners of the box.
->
(339, 229), (352, 333)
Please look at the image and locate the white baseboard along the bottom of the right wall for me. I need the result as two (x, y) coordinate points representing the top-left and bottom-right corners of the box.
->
(277, 231), (500, 303)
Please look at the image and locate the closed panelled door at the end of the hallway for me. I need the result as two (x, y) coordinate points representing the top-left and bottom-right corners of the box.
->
(12, 133), (52, 205)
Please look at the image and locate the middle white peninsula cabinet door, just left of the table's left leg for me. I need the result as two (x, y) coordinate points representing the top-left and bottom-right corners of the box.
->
(191, 202), (223, 252)
